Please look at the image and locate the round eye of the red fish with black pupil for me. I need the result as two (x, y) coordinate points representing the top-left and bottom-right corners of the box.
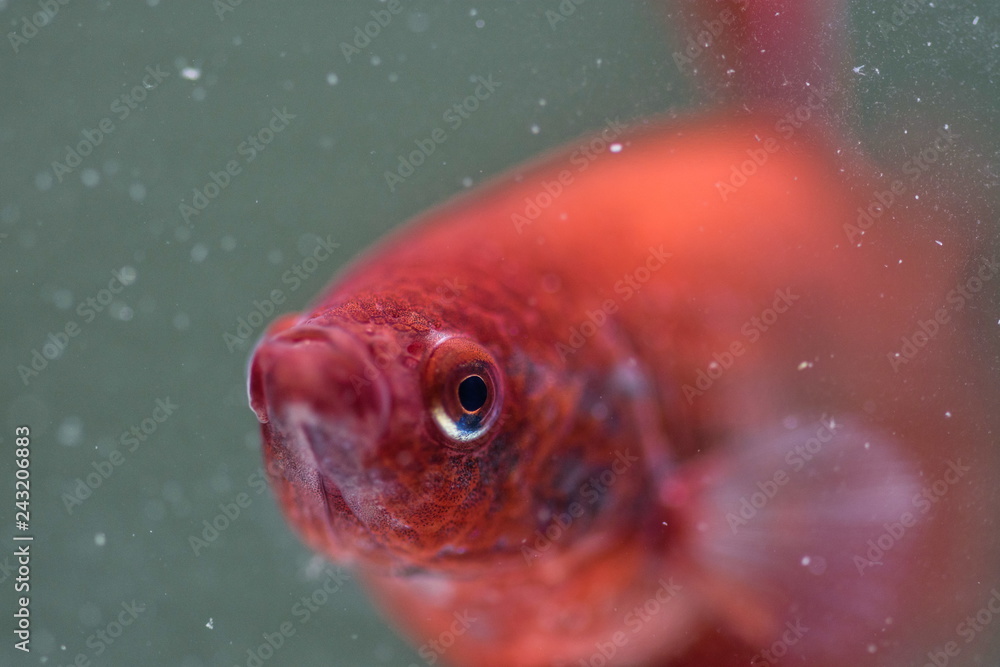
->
(424, 337), (503, 451)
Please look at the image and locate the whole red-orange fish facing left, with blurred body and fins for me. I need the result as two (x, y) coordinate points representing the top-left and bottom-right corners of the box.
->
(249, 2), (996, 666)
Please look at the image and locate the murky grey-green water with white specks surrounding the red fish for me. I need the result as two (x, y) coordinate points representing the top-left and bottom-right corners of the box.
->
(0, 0), (1000, 667)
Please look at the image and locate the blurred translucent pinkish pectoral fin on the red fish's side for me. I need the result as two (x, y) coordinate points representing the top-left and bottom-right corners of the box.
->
(662, 419), (922, 664)
